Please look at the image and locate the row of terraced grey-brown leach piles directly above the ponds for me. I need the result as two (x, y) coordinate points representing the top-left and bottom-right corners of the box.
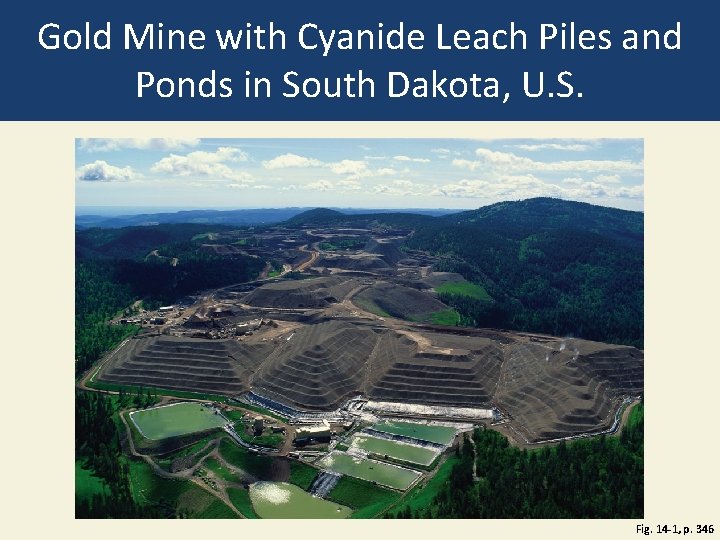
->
(99, 320), (644, 442)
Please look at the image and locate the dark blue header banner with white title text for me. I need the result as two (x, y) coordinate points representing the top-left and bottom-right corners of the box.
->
(0, 0), (720, 121)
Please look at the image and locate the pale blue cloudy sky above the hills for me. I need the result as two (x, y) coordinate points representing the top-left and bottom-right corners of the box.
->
(75, 139), (643, 210)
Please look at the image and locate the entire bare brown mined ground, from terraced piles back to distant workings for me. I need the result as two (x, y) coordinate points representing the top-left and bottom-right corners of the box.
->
(88, 229), (644, 442)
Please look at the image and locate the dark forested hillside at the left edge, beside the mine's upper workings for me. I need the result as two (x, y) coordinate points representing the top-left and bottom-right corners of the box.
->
(75, 224), (265, 373)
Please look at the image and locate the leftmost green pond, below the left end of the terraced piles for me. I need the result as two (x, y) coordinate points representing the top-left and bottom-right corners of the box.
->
(130, 402), (227, 440)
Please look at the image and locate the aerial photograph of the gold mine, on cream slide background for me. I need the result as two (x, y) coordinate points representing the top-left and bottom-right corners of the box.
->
(76, 138), (644, 519)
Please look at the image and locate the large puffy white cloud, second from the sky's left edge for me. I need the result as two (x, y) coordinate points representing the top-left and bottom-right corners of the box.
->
(150, 147), (251, 180)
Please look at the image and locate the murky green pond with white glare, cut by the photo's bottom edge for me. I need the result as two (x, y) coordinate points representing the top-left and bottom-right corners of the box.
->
(250, 482), (352, 519)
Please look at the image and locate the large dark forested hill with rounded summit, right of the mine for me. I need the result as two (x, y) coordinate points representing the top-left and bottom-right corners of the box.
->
(405, 198), (644, 348)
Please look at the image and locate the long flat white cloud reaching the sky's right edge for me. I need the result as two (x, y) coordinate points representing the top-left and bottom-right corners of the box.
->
(452, 148), (643, 173)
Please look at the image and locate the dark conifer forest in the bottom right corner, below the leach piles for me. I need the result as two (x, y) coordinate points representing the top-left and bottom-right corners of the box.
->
(387, 404), (644, 519)
